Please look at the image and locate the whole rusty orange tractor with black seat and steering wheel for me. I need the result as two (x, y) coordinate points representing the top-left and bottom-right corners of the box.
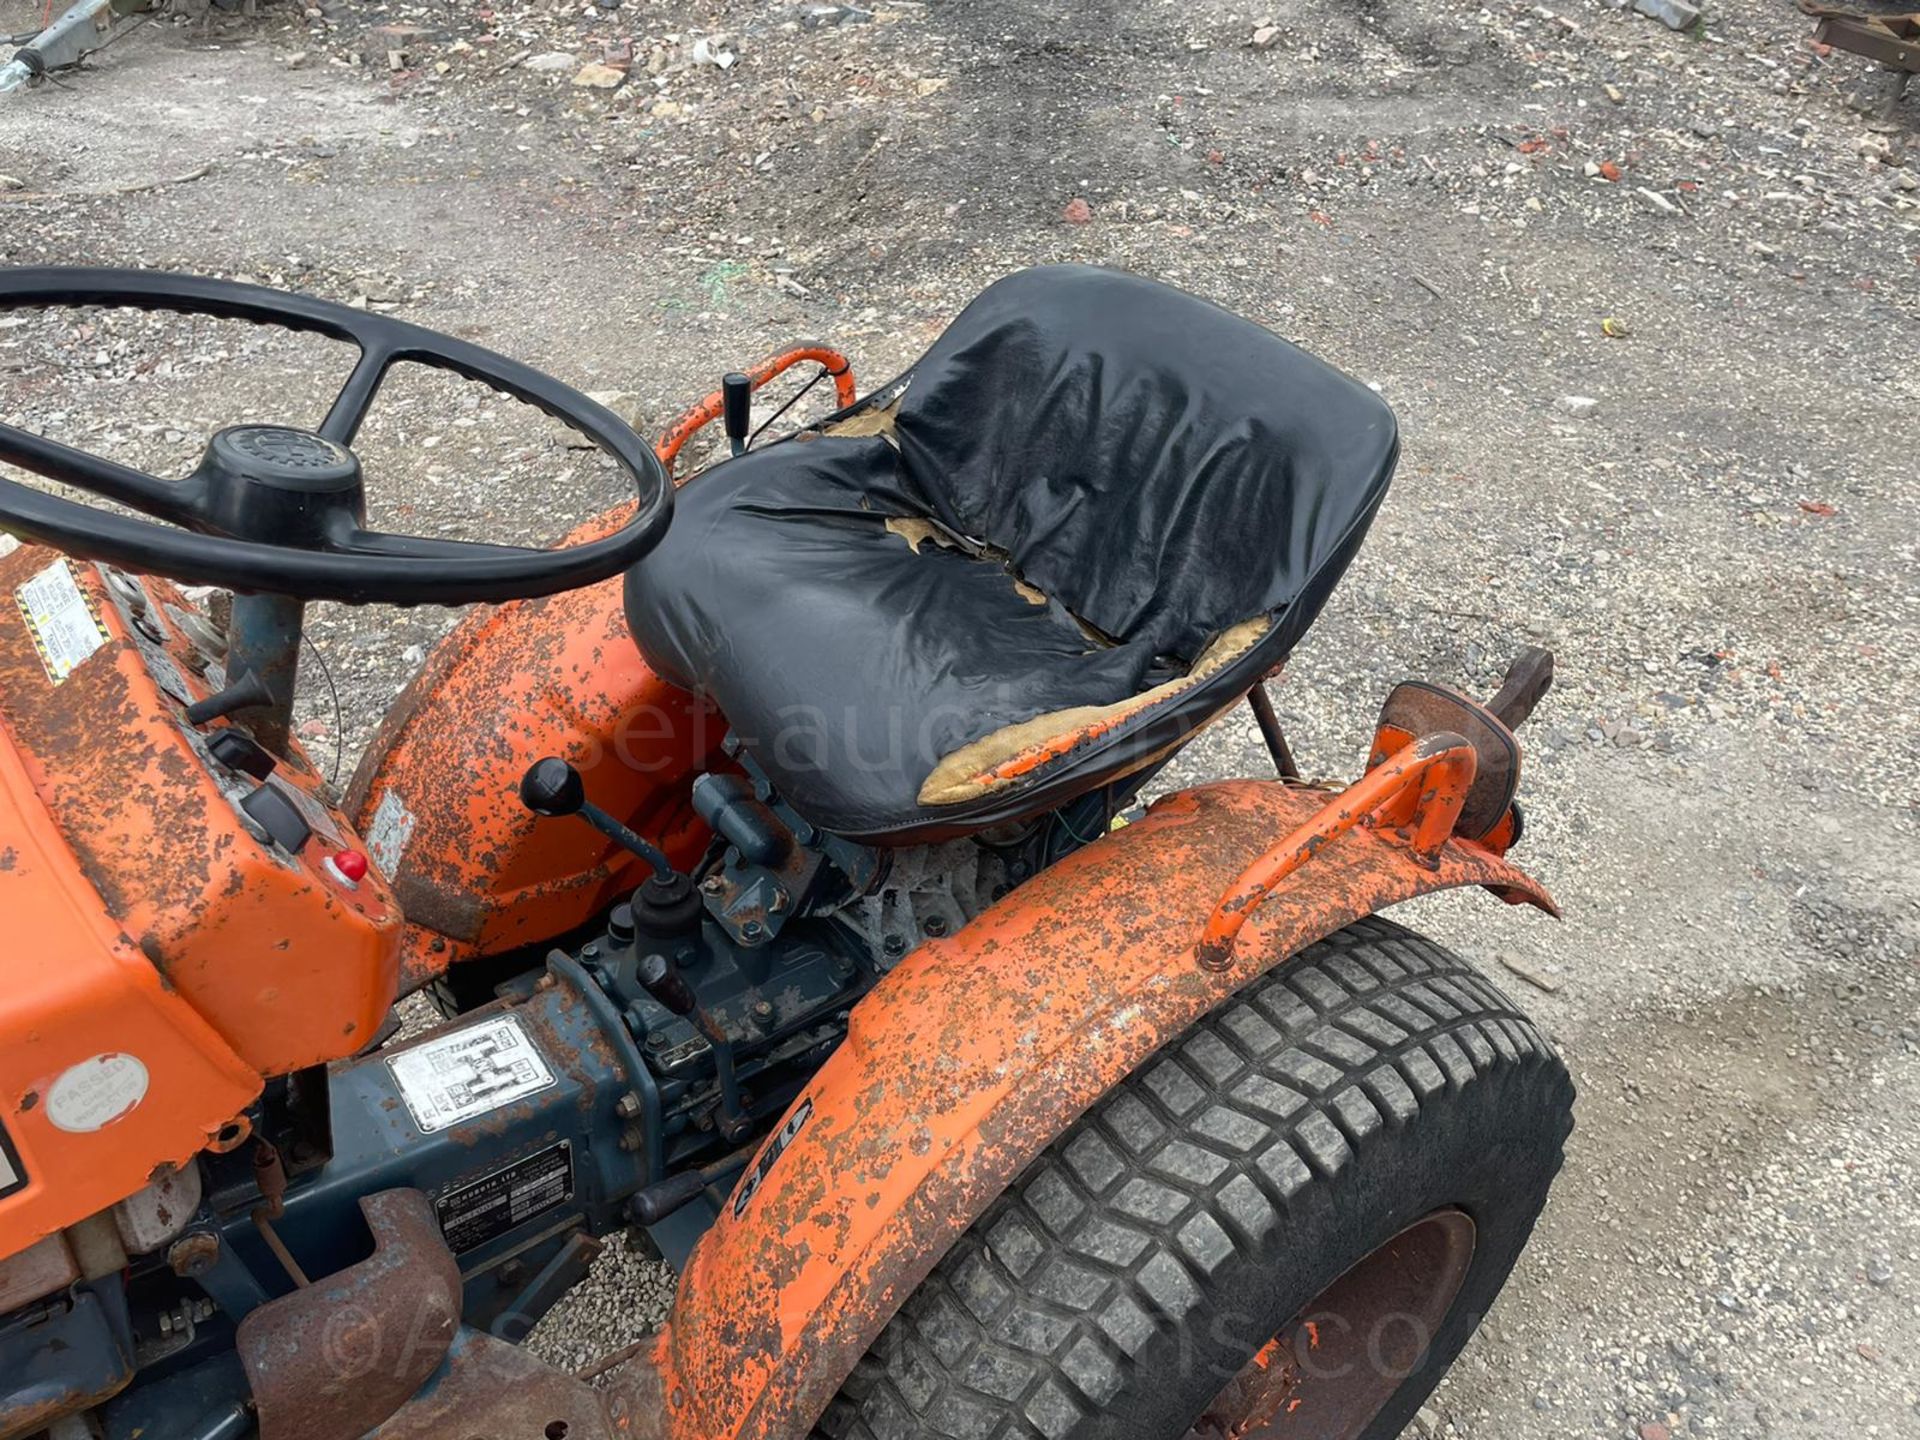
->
(0, 267), (1572, 1440)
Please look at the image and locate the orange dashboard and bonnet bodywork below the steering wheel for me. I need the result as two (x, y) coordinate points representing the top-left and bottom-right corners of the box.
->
(0, 547), (399, 1256)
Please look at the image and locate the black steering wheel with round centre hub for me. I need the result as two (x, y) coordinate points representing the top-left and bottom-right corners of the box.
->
(0, 267), (674, 605)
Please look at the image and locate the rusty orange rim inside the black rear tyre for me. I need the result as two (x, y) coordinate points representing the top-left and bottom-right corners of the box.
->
(1187, 1210), (1475, 1440)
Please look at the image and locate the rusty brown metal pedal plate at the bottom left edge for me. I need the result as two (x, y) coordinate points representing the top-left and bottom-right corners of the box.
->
(238, 1190), (461, 1440)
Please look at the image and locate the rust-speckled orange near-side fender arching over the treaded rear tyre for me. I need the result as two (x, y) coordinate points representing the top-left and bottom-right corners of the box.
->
(636, 779), (1553, 1440)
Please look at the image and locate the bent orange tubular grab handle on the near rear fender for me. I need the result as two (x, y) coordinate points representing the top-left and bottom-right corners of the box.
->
(1198, 733), (1478, 972)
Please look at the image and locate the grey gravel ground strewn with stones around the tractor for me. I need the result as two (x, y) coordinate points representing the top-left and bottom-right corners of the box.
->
(0, 0), (1920, 1440)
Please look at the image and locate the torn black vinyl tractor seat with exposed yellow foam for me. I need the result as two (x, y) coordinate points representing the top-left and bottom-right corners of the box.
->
(626, 265), (1398, 845)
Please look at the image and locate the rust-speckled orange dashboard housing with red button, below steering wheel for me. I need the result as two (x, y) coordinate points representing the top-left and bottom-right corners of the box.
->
(0, 547), (401, 1082)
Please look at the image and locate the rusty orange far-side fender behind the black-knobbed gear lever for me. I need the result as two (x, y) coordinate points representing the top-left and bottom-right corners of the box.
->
(348, 568), (726, 991)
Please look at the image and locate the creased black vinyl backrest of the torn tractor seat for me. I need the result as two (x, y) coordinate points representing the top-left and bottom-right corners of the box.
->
(893, 265), (1398, 662)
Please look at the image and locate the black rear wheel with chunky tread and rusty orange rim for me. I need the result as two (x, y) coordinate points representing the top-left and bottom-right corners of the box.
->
(816, 918), (1572, 1440)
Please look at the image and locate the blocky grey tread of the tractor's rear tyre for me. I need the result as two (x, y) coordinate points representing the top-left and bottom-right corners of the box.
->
(816, 918), (1571, 1440)
